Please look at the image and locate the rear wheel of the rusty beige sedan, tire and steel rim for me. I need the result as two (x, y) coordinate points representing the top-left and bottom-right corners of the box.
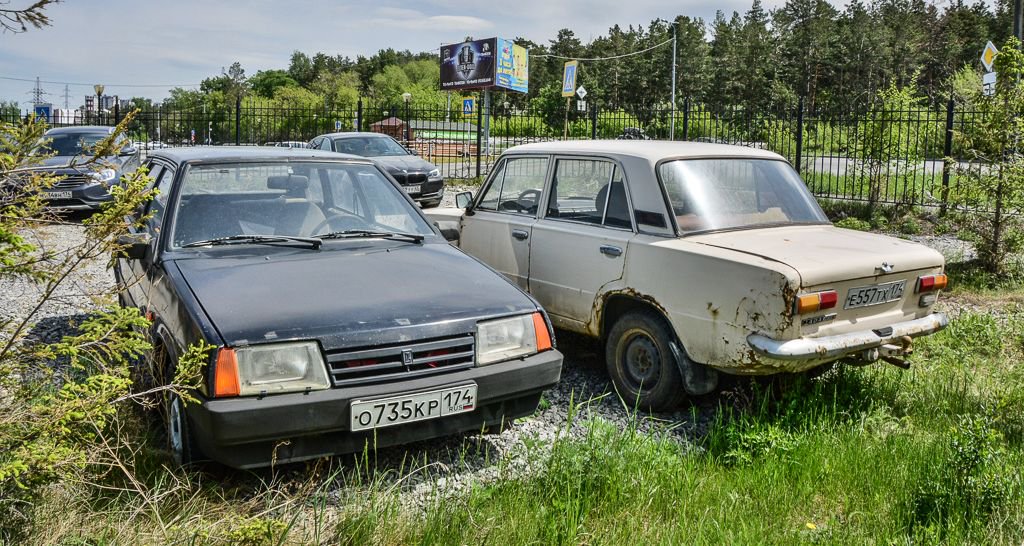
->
(604, 311), (685, 411)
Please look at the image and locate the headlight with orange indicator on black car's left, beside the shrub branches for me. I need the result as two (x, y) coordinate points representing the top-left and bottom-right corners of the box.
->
(214, 341), (331, 396)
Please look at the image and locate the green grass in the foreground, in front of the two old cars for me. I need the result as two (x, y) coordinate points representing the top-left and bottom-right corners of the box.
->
(16, 297), (1024, 544)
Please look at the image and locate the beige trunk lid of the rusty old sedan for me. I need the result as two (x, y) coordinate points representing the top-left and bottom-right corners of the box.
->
(686, 225), (945, 287)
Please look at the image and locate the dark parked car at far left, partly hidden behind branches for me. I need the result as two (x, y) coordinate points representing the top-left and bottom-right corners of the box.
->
(23, 126), (139, 210)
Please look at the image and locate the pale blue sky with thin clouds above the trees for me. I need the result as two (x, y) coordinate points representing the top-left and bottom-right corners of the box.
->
(0, 0), (838, 109)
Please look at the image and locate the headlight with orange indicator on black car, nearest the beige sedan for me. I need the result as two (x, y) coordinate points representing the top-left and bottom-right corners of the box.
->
(476, 312), (551, 366)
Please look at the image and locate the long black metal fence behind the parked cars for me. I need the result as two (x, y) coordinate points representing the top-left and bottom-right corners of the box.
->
(5, 95), (986, 210)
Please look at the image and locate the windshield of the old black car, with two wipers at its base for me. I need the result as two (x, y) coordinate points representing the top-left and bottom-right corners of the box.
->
(171, 162), (433, 247)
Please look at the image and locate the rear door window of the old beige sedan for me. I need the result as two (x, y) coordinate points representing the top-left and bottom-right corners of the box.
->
(547, 159), (633, 228)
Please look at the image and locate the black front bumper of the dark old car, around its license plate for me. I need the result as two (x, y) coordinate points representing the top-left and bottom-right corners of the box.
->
(185, 349), (562, 468)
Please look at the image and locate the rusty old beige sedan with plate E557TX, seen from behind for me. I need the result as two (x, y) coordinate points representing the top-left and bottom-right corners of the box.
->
(428, 140), (947, 409)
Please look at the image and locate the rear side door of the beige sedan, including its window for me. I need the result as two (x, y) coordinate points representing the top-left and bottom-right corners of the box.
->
(529, 158), (634, 331)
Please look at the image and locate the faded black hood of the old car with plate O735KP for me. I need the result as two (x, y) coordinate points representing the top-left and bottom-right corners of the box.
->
(173, 241), (537, 350)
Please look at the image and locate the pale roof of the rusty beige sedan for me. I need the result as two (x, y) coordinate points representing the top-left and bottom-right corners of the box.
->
(505, 140), (785, 162)
